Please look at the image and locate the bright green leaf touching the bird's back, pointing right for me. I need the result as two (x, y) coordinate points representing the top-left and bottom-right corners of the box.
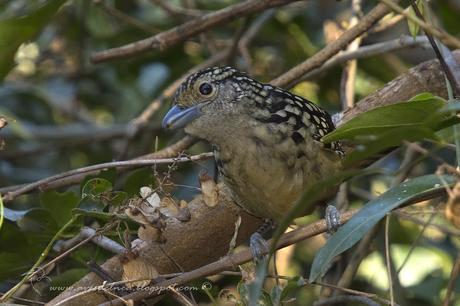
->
(322, 93), (446, 143)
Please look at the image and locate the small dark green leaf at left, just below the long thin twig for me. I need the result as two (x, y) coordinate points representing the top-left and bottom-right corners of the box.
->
(40, 191), (80, 227)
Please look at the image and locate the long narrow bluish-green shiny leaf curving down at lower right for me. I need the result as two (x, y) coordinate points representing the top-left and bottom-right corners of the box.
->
(309, 175), (456, 282)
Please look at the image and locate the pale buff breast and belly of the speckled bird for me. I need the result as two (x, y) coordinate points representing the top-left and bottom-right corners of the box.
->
(220, 135), (336, 221)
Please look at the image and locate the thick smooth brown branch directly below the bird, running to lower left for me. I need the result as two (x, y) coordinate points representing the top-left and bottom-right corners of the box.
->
(49, 185), (262, 306)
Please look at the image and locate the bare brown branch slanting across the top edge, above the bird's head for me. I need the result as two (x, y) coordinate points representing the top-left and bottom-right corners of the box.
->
(91, 0), (298, 63)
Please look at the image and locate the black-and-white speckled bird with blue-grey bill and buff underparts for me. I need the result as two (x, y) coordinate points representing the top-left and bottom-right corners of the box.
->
(163, 67), (345, 256)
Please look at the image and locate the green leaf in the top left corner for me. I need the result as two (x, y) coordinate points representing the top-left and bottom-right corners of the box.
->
(0, 0), (66, 81)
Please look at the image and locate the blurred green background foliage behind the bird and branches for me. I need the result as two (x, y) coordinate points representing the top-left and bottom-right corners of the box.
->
(0, 0), (460, 306)
